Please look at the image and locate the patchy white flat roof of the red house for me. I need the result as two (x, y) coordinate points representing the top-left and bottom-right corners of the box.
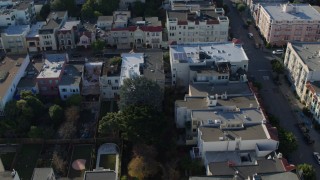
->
(37, 54), (66, 79)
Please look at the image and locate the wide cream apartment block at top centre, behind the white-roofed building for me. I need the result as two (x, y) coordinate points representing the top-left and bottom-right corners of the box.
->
(166, 10), (229, 43)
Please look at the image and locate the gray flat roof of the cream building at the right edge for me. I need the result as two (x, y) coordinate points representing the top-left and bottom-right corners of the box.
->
(291, 42), (320, 71)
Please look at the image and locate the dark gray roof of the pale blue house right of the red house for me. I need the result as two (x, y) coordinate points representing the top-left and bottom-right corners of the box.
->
(59, 64), (83, 86)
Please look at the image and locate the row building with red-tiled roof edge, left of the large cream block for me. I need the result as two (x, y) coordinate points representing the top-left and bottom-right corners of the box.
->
(107, 17), (162, 49)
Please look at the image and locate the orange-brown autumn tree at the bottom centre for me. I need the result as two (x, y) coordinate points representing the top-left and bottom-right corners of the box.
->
(128, 156), (159, 180)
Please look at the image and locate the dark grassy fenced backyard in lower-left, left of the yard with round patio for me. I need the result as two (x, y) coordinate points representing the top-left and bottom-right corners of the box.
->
(13, 144), (42, 179)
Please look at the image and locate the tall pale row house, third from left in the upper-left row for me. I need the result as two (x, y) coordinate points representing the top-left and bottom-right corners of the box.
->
(39, 11), (68, 51)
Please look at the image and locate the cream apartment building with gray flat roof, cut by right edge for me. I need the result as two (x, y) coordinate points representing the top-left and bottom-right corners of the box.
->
(284, 42), (320, 102)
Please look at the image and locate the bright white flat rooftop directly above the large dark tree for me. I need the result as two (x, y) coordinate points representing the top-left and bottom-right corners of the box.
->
(120, 53), (144, 85)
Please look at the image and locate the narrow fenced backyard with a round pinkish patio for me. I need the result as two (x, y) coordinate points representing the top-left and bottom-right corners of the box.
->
(68, 144), (93, 179)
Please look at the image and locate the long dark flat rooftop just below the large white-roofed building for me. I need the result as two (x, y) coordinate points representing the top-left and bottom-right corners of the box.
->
(189, 83), (253, 97)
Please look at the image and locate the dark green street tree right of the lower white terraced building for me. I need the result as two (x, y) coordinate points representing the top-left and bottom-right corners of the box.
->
(278, 127), (298, 156)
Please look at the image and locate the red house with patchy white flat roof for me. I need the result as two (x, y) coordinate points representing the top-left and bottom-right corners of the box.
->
(36, 54), (67, 96)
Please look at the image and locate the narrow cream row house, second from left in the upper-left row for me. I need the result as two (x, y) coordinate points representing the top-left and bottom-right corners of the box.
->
(26, 21), (46, 52)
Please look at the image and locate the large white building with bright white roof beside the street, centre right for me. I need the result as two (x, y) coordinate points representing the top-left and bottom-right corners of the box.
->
(169, 42), (249, 88)
